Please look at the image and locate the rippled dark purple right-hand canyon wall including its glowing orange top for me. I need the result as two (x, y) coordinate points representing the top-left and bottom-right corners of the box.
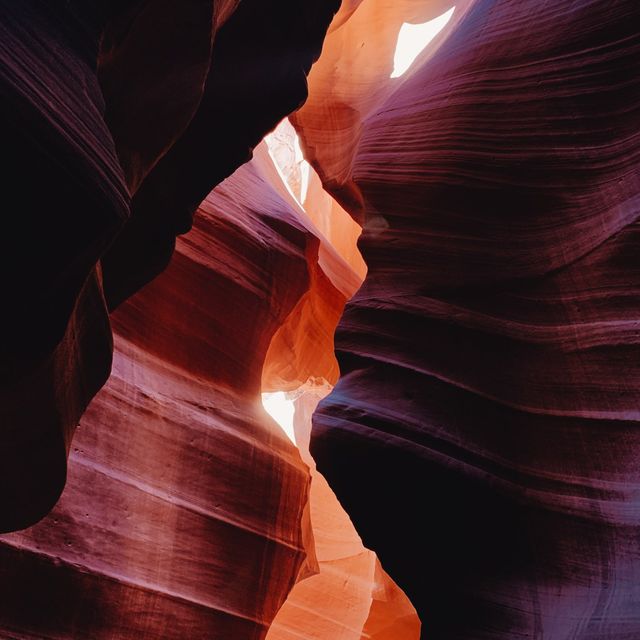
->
(293, 0), (640, 640)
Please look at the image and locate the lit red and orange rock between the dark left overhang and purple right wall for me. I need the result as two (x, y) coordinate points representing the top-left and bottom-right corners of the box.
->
(0, 115), (420, 640)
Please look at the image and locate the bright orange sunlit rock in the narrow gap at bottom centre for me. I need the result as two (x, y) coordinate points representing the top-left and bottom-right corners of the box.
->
(267, 379), (420, 640)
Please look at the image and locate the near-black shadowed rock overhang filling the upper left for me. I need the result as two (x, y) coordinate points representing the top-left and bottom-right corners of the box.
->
(0, 0), (337, 531)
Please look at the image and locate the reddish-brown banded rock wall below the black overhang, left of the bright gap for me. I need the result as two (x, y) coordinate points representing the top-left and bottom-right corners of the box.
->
(0, 154), (317, 640)
